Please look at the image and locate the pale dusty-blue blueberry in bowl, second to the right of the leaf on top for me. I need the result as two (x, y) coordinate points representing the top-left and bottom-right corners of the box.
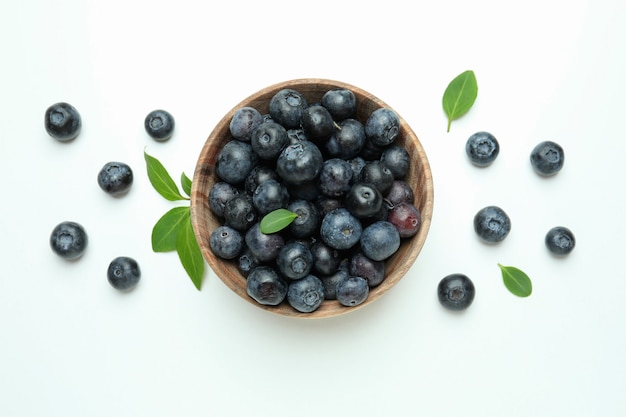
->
(320, 208), (364, 250)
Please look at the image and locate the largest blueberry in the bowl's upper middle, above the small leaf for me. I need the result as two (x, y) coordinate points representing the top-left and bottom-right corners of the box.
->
(276, 140), (324, 184)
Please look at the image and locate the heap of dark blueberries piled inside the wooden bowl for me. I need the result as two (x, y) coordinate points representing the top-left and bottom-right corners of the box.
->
(209, 88), (421, 313)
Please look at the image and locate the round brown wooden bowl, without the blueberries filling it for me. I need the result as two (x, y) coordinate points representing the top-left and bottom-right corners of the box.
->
(191, 78), (433, 318)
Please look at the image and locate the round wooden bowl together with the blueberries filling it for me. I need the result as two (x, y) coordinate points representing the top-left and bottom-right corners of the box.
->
(191, 78), (434, 319)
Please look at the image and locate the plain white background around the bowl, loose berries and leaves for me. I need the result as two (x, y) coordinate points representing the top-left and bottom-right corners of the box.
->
(0, 0), (626, 417)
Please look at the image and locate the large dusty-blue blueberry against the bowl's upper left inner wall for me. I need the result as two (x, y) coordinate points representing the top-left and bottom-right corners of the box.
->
(215, 139), (258, 185)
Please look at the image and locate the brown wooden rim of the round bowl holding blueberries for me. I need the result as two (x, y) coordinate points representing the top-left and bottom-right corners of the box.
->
(190, 78), (434, 319)
